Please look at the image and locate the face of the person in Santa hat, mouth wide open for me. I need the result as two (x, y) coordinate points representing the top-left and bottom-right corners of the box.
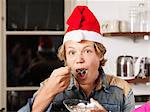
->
(65, 40), (100, 84)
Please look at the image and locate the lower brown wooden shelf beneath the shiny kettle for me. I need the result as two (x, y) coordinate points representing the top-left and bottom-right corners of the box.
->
(126, 76), (150, 83)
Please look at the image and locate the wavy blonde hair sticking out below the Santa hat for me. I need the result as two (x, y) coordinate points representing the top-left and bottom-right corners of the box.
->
(57, 42), (107, 66)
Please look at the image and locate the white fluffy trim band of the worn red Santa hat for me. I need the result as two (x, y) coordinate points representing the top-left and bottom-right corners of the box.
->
(63, 30), (102, 44)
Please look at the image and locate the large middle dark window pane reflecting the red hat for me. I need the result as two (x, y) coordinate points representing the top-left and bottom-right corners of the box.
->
(6, 35), (63, 87)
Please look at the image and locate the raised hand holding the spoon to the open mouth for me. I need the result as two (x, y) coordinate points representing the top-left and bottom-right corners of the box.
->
(45, 66), (71, 96)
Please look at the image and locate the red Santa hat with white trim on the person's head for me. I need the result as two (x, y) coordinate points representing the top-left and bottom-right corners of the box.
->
(63, 6), (102, 43)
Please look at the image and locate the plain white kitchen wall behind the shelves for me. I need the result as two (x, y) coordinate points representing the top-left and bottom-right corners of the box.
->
(87, 0), (150, 75)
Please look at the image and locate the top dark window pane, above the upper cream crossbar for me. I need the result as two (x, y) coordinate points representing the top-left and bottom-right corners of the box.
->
(6, 0), (64, 31)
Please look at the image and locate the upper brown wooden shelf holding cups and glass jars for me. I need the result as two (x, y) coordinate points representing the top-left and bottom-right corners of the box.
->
(103, 32), (150, 37)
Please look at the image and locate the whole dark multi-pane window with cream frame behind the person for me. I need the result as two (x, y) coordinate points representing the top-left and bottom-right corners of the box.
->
(0, 0), (71, 111)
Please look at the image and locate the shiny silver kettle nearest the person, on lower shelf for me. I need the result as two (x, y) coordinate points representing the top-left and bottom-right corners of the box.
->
(117, 55), (141, 79)
